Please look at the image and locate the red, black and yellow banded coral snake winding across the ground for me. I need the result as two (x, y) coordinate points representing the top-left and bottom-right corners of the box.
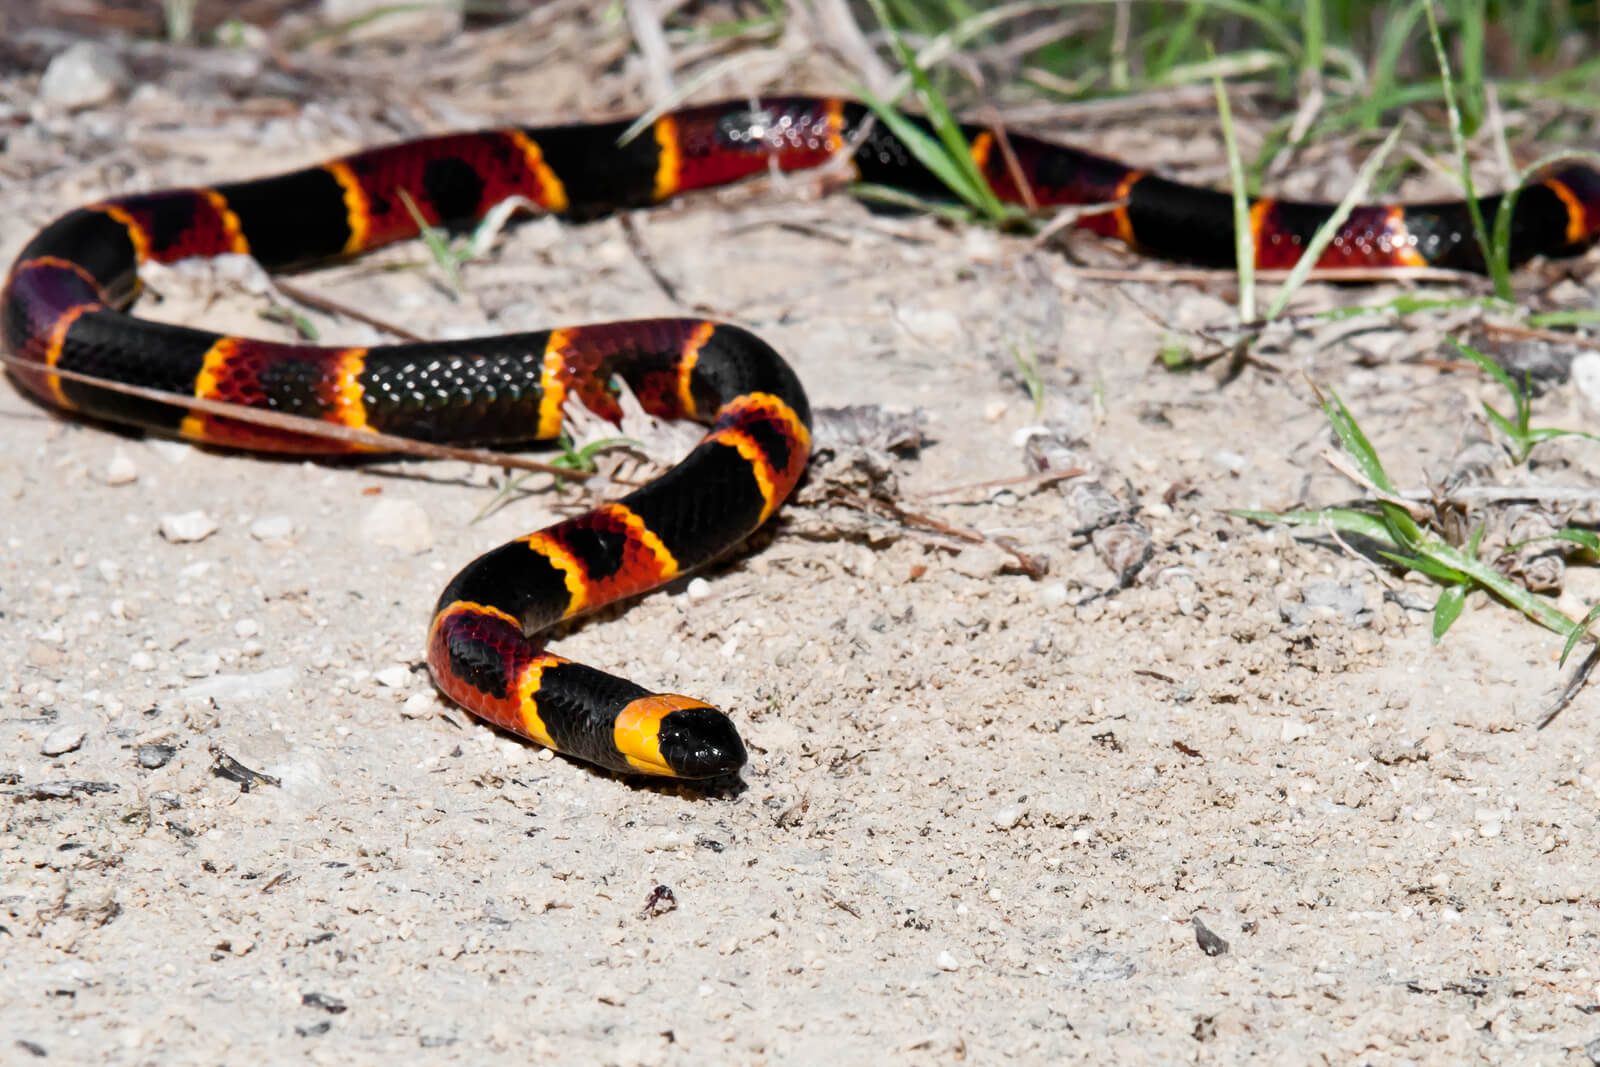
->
(0, 96), (1600, 777)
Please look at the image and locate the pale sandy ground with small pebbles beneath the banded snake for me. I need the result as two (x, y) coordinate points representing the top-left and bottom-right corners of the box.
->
(9, 10), (1600, 1064)
